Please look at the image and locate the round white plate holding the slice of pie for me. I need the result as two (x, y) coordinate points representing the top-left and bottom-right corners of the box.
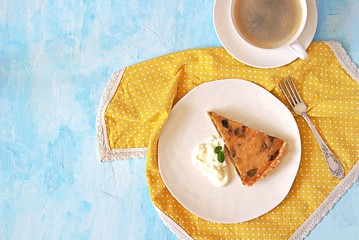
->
(158, 79), (301, 223)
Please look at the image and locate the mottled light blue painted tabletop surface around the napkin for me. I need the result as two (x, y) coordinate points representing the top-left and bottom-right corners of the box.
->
(0, 0), (359, 239)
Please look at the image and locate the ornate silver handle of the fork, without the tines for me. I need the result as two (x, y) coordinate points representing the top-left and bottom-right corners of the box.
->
(301, 113), (344, 179)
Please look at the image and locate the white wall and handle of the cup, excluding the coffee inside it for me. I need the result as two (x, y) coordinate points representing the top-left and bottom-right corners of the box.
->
(230, 0), (308, 59)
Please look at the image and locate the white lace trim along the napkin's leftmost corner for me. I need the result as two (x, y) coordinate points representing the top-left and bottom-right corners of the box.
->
(96, 69), (147, 162)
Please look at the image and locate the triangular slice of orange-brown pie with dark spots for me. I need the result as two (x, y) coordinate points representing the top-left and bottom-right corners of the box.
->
(208, 112), (286, 186)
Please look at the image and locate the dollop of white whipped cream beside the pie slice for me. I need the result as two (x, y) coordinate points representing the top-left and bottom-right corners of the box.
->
(192, 136), (229, 187)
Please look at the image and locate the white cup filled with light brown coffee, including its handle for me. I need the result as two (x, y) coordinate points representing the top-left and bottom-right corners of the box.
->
(231, 0), (307, 59)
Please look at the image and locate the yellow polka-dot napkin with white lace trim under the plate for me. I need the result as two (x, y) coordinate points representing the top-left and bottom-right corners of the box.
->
(97, 42), (359, 239)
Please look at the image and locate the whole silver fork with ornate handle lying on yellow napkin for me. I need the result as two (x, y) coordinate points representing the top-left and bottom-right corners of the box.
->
(278, 77), (344, 179)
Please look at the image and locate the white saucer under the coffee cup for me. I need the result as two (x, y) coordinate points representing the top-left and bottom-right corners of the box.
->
(213, 0), (318, 68)
